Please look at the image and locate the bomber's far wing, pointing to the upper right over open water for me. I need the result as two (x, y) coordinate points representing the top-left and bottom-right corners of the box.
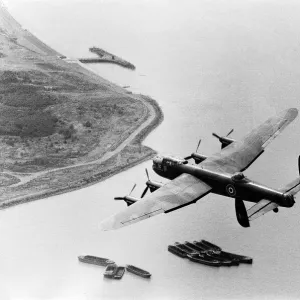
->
(200, 108), (298, 174)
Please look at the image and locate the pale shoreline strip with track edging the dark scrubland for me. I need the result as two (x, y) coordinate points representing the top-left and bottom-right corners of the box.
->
(0, 2), (163, 209)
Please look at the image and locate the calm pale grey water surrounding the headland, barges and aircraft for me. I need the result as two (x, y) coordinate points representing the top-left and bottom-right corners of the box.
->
(0, 0), (300, 299)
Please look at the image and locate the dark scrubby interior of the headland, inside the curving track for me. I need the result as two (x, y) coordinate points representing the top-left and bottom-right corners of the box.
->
(0, 45), (151, 172)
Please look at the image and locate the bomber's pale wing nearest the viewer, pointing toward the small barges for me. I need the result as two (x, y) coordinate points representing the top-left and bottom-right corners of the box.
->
(100, 173), (212, 230)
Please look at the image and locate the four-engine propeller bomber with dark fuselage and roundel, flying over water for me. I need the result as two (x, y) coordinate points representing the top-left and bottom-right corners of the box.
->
(100, 108), (300, 230)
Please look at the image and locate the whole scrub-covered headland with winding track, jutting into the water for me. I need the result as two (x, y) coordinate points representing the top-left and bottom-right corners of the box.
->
(0, 1), (163, 208)
